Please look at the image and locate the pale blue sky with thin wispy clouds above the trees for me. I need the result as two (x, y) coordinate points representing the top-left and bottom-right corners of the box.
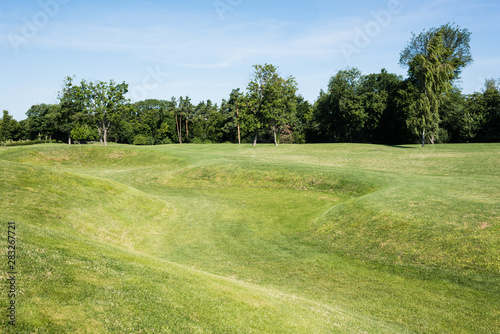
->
(0, 0), (500, 120)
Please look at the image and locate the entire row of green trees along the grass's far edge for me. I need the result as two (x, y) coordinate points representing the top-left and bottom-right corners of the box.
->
(0, 24), (500, 145)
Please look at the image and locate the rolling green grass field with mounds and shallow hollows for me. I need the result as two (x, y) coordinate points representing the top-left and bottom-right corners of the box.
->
(0, 144), (500, 333)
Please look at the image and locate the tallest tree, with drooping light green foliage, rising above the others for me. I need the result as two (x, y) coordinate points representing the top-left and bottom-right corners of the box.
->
(400, 24), (472, 146)
